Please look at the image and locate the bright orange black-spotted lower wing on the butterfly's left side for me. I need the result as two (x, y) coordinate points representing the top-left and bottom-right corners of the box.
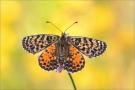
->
(38, 43), (59, 71)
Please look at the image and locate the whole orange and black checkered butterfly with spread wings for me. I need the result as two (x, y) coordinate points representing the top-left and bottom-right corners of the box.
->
(22, 22), (107, 73)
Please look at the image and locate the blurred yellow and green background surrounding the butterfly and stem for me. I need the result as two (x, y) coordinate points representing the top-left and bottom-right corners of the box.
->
(0, 0), (135, 90)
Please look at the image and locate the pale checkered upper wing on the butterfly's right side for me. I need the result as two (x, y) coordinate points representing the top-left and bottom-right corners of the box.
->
(68, 36), (107, 58)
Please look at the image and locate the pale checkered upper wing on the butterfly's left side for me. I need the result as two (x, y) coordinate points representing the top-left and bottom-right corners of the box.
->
(22, 34), (59, 54)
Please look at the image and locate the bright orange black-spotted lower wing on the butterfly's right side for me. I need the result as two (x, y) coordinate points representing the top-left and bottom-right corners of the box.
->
(63, 43), (85, 73)
